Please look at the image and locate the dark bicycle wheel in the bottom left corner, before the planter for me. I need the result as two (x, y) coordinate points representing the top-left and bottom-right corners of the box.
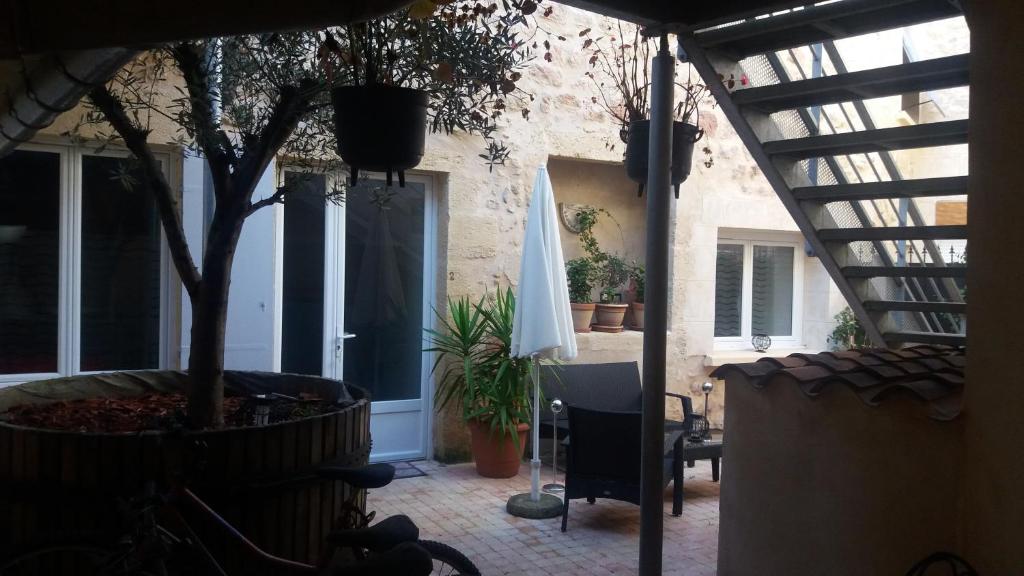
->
(0, 542), (123, 576)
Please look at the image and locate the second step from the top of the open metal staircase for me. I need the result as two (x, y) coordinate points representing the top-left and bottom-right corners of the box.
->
(732, 54), (969, 113)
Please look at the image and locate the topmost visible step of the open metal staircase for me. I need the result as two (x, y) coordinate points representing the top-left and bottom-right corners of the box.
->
(694, 0), (963, 60)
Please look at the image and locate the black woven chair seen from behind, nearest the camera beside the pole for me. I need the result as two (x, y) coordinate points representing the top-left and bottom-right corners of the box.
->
(562, 404), (685, 532)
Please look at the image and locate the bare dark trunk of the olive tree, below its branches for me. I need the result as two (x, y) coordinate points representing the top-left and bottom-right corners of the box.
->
(188, 210), (245, 428)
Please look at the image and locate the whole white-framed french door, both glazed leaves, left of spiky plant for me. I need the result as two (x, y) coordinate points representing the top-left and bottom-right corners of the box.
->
(282, 171), (435, 460)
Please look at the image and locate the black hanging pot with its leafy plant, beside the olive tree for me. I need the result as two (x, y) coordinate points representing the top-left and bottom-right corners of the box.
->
(317, 0), (537, 186)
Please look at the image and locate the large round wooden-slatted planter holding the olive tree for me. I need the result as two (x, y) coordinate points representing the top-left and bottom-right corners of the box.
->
(0, 371), (370, 574)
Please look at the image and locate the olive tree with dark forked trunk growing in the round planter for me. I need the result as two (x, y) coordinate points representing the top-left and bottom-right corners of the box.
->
(69, 0), (536, 428)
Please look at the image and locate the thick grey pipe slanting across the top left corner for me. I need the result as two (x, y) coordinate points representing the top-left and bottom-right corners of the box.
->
(0, 48), (136, 157)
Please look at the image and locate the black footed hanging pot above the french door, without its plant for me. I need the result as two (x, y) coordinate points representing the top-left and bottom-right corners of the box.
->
(331, 84), (429, 187)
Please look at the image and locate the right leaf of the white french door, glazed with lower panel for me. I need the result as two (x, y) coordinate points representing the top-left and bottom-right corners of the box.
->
(344, 177), (434, 460)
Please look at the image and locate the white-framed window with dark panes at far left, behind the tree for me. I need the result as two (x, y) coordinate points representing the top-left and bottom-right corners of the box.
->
(0, 146), (166, 382)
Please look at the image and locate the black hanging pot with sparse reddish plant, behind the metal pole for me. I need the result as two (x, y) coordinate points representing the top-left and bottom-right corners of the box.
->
(580, 22), (713, 198)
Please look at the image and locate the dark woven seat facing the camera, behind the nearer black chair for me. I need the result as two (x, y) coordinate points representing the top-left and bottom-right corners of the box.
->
(541, 362), (693, 438)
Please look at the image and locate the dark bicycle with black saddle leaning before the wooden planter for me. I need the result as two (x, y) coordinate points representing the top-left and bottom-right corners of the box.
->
(0, 464), (480, 576)
